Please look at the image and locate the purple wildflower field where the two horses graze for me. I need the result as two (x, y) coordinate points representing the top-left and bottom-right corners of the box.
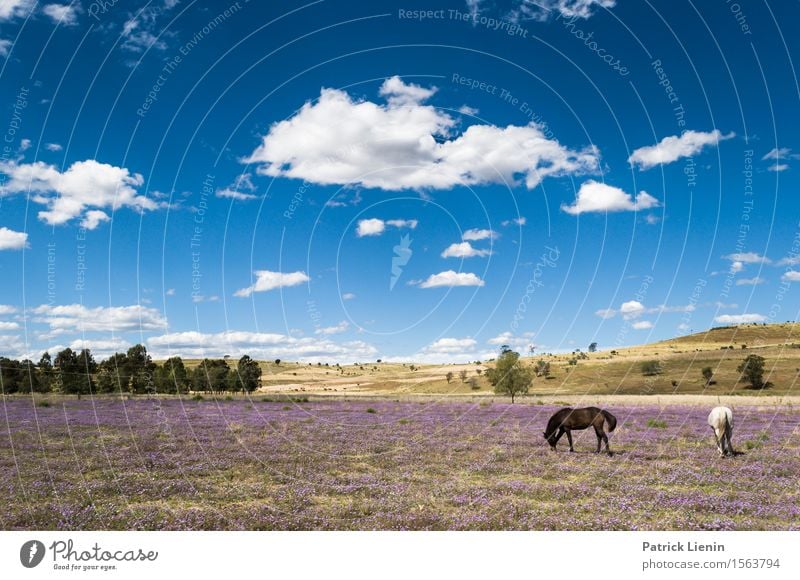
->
(0, 398), (800, 530)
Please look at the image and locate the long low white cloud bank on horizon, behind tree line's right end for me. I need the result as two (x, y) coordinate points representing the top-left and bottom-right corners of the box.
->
(147, 330), (378, 363)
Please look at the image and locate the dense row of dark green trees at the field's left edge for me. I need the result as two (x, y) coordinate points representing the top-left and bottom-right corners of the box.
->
(0, 344), (261, 395)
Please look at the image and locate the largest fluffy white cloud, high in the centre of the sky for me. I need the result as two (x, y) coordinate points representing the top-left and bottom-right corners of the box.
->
(244, 77), (599, 191)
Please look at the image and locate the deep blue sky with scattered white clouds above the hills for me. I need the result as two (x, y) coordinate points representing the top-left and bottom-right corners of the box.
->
(0, 0), (800, 363)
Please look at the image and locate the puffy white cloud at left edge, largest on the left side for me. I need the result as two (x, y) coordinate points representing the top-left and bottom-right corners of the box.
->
(0, 159), (158, 227)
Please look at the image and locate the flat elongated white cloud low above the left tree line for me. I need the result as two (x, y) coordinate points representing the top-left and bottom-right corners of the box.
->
(31, 304), (167, 336)
